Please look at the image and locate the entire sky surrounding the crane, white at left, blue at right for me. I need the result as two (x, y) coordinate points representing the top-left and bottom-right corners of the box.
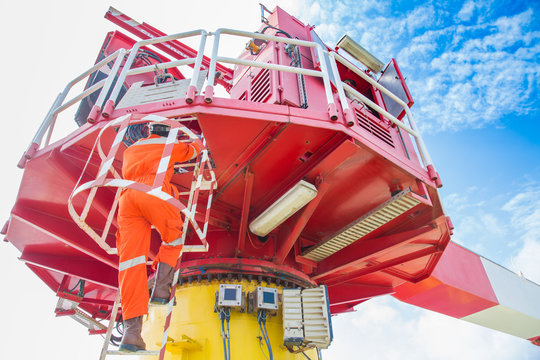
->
(0, 0), (540, 359)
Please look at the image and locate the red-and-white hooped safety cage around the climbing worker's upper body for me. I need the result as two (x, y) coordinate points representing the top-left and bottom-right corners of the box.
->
(68, 114), (216, 254)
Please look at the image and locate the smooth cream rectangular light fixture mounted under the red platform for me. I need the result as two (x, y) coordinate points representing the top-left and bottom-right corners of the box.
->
(249, 180), (317, 236)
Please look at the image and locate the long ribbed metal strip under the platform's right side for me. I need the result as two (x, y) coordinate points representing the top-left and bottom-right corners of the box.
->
(303, 188), (421, 261)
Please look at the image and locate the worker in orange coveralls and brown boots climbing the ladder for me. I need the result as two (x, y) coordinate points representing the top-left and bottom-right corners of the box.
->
(116, 123), (202, 352)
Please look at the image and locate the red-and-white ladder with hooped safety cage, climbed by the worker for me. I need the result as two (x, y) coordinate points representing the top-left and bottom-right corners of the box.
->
(68, 115), (217, 360)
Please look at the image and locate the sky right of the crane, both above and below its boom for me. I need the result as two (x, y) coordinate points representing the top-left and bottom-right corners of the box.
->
(307, 1), (540, 359)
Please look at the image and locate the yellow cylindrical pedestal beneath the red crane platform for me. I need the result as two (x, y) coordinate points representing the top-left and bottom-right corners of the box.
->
(139, 280), (317, 360)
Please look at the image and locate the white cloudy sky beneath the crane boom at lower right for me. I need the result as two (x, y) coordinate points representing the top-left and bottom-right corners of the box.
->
(323, 297), (536, 360)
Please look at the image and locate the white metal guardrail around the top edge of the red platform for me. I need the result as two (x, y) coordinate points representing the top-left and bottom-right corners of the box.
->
(19, 28), (437, 180)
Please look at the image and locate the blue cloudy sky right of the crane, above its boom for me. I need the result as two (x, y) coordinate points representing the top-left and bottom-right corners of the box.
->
(305, 1), (540, 268)
